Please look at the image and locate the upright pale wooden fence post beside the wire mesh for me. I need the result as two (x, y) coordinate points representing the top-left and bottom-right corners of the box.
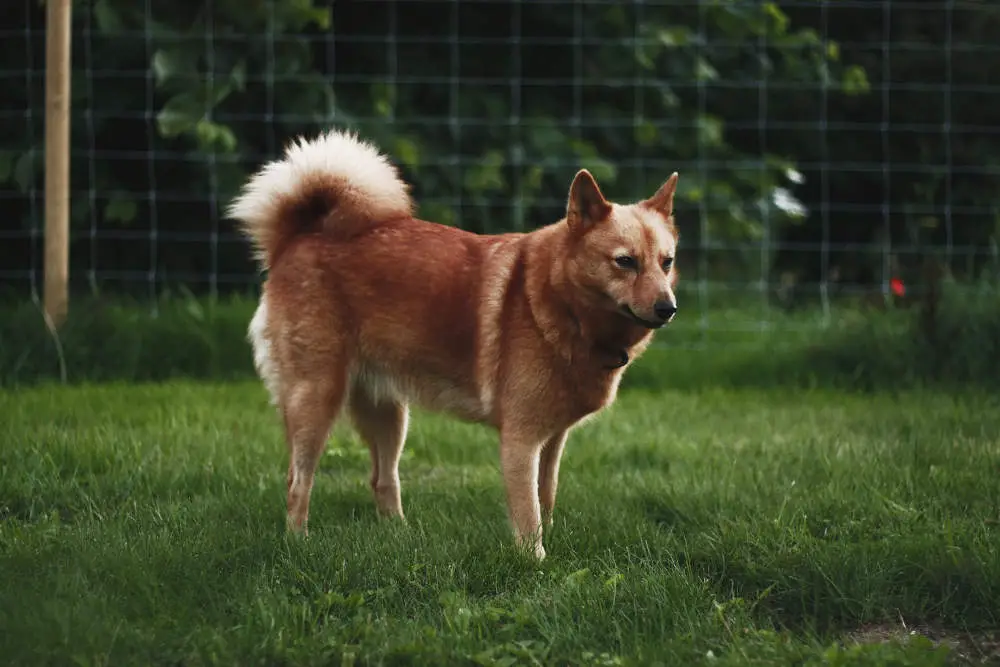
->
(44, 0), (72, 326)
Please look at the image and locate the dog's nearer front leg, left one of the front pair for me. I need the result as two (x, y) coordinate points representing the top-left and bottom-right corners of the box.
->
(500, 429), (545, 560)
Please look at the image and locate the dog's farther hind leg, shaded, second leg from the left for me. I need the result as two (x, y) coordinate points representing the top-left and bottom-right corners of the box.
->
(350, 385), (409, 518)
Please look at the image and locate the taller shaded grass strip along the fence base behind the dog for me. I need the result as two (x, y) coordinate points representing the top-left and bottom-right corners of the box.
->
(7, 273), (1000, 391)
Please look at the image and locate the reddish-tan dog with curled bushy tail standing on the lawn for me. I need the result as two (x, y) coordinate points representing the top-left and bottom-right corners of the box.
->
(227, 130), (678, 559)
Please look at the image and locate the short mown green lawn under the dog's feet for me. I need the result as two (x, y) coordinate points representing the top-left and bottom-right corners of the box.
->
(0, 380), (1000, 665)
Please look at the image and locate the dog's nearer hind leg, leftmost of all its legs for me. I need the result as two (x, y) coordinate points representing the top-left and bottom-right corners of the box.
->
(282, 373), (347, 532)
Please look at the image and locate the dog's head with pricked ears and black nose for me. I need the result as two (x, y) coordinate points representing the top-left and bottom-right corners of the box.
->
(566, 169), (678, 329)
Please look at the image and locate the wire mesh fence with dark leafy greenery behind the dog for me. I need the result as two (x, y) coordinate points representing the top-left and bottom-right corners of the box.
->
(0, 0), (1000, 344)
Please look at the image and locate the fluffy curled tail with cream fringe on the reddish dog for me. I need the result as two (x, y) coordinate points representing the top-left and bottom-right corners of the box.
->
(227, 130), (413, 269)
